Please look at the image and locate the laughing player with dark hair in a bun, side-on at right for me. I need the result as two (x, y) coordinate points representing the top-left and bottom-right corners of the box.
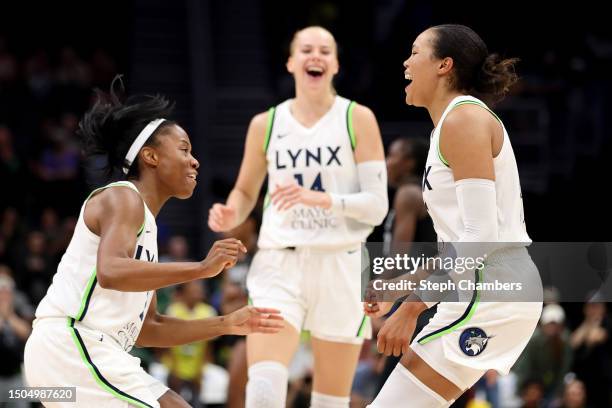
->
(364, 25), (542, 408)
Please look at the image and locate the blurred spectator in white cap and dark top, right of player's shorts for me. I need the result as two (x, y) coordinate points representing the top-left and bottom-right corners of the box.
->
(514, 304), (573, 402)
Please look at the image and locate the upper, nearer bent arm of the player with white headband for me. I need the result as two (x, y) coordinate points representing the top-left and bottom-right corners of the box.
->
(91, 187), (246, 292)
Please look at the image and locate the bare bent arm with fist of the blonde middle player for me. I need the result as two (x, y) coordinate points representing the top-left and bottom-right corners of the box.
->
(208, 112), (270, 232)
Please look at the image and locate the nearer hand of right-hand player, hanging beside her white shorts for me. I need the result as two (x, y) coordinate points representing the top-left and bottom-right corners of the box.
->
(376, 303), (418, 357)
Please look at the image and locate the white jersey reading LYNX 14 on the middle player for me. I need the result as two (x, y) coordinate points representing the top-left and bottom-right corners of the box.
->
(258, 96), (373, 248)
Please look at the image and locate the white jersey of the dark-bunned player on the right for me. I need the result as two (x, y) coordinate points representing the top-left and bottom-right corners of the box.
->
(422, 95), (531, 245)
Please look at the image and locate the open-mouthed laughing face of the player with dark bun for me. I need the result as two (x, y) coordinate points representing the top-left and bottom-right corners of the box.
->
(404, 29), (452, 106)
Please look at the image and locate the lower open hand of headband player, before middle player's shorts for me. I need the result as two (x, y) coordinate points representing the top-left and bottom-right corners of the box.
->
(227, 306), (285, 336)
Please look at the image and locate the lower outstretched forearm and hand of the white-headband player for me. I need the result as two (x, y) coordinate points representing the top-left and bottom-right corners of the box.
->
(136, 295), (283, 347)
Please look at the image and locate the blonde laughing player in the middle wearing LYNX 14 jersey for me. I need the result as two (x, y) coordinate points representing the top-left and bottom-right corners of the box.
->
(209, 27), (388, 408)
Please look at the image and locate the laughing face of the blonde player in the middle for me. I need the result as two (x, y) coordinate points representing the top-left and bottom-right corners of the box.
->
(287, 27), (339, 90)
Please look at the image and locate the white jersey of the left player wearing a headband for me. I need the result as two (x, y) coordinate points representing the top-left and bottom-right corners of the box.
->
(36, 181), (158, 351)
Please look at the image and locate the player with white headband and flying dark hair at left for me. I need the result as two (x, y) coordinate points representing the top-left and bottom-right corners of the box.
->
(24, 78), (282, 407)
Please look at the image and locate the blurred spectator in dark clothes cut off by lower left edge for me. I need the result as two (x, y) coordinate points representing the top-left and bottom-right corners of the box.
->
(0, 265), (33, 407)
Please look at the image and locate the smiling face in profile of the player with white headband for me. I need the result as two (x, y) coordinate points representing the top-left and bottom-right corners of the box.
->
(140, 124), (200, 199)
